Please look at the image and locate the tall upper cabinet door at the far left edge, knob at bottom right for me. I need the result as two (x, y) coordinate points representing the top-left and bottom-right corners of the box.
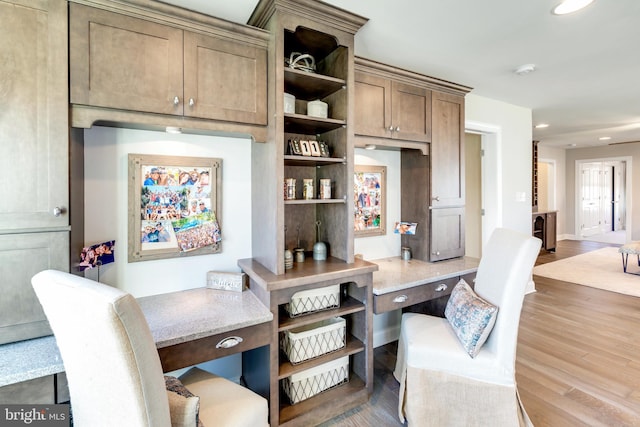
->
(0, 0), (69, 233)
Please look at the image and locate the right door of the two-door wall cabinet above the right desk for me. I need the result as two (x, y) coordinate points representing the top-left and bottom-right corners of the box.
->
(391, 82), (431, 142)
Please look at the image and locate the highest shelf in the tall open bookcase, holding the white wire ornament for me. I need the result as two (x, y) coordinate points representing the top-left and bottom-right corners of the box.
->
(284, 67), (347, 101)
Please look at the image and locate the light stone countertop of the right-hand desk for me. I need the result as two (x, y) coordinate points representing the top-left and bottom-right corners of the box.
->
(369, 257), (480, 295)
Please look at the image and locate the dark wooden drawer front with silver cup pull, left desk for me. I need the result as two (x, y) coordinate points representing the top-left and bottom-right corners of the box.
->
(158, 322), (273, 372)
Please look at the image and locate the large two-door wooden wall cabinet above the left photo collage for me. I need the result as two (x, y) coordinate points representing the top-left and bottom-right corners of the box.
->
(69, 1), (267, 137)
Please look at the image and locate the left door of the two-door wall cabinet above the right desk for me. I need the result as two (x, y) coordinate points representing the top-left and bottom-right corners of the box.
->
(354, 73), (391, 138)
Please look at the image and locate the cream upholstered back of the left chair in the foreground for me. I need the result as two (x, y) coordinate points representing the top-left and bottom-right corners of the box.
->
(31, 270), (171, 427)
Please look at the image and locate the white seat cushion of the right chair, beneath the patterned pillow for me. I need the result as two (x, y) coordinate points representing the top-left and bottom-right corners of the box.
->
(401, 313), (515, 385)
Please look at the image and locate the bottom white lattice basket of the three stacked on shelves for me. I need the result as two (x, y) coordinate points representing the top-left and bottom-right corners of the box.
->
(282, 356), (349, 404)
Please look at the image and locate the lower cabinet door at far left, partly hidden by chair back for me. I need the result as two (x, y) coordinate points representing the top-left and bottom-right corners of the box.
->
(0, 231), (69, 344)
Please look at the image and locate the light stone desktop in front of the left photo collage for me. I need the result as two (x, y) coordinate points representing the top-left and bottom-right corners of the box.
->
(138, 288), (273, 348)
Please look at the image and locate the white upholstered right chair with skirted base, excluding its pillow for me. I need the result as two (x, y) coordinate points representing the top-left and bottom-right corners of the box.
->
(394, 229), (541, 427)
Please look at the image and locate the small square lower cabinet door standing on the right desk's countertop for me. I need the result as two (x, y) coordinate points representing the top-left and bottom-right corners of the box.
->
(430, 207), (465, 261)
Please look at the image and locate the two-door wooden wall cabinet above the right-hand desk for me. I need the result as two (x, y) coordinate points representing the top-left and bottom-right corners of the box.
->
(354, 72), (431, 142)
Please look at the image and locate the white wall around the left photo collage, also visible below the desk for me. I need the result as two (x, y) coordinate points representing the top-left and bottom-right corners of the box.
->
(84, 127), (252, 381)
